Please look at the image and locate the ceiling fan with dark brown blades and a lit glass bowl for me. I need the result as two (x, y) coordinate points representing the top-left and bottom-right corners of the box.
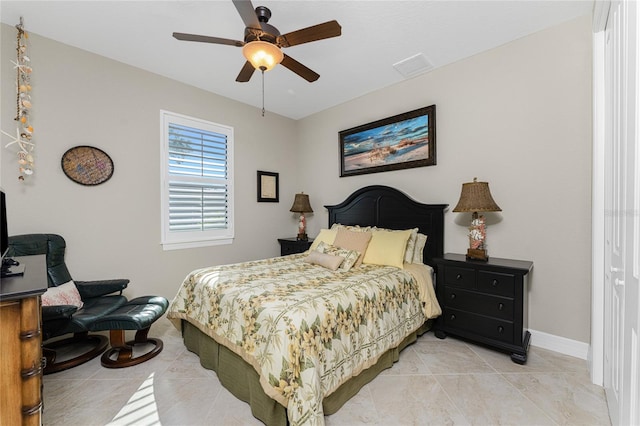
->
(173, 0), (342, 83)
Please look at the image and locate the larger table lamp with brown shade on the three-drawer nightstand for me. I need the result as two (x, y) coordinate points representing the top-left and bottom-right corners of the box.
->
(453, 178), (502, 262)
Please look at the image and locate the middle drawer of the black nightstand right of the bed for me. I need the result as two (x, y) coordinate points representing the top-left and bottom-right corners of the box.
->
(443, 287), (514, 320)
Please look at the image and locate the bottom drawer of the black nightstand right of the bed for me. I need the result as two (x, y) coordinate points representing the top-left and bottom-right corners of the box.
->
(443, 308), (514, 343)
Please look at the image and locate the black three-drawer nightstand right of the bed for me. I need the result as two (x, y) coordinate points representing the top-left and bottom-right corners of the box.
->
(434, 253), (533, 364)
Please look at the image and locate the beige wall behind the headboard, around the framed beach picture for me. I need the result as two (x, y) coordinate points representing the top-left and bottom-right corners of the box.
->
(299, 17), (591, 342)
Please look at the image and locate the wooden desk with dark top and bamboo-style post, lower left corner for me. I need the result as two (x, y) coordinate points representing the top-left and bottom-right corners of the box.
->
(0, 255), (47, 426)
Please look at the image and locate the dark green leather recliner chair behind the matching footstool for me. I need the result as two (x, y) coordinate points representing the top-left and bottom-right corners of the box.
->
(9, 234), (129, 374)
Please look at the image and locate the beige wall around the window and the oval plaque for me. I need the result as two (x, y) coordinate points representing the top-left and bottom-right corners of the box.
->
(0, 25), (299, 297)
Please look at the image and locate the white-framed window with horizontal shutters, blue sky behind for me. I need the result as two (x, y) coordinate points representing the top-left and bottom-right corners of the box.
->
(160, 111), (234, 250)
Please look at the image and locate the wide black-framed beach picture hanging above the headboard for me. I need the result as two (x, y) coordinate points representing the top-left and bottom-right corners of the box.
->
(339, 105), (436, 177)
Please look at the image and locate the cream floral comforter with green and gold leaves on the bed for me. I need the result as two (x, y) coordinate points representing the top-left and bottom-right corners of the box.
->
(167, 254), (441, 425)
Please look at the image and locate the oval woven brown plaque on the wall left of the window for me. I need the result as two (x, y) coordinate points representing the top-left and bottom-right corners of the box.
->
(61, 145), (113, 185)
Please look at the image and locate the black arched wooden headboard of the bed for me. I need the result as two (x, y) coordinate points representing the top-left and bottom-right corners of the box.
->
(325, 185), (448, 265)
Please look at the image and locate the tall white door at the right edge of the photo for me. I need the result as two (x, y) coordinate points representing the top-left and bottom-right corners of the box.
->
(604, 1), (640, 425)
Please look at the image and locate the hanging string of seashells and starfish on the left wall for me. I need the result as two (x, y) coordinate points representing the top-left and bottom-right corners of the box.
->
(2, 17), (35, 181)
